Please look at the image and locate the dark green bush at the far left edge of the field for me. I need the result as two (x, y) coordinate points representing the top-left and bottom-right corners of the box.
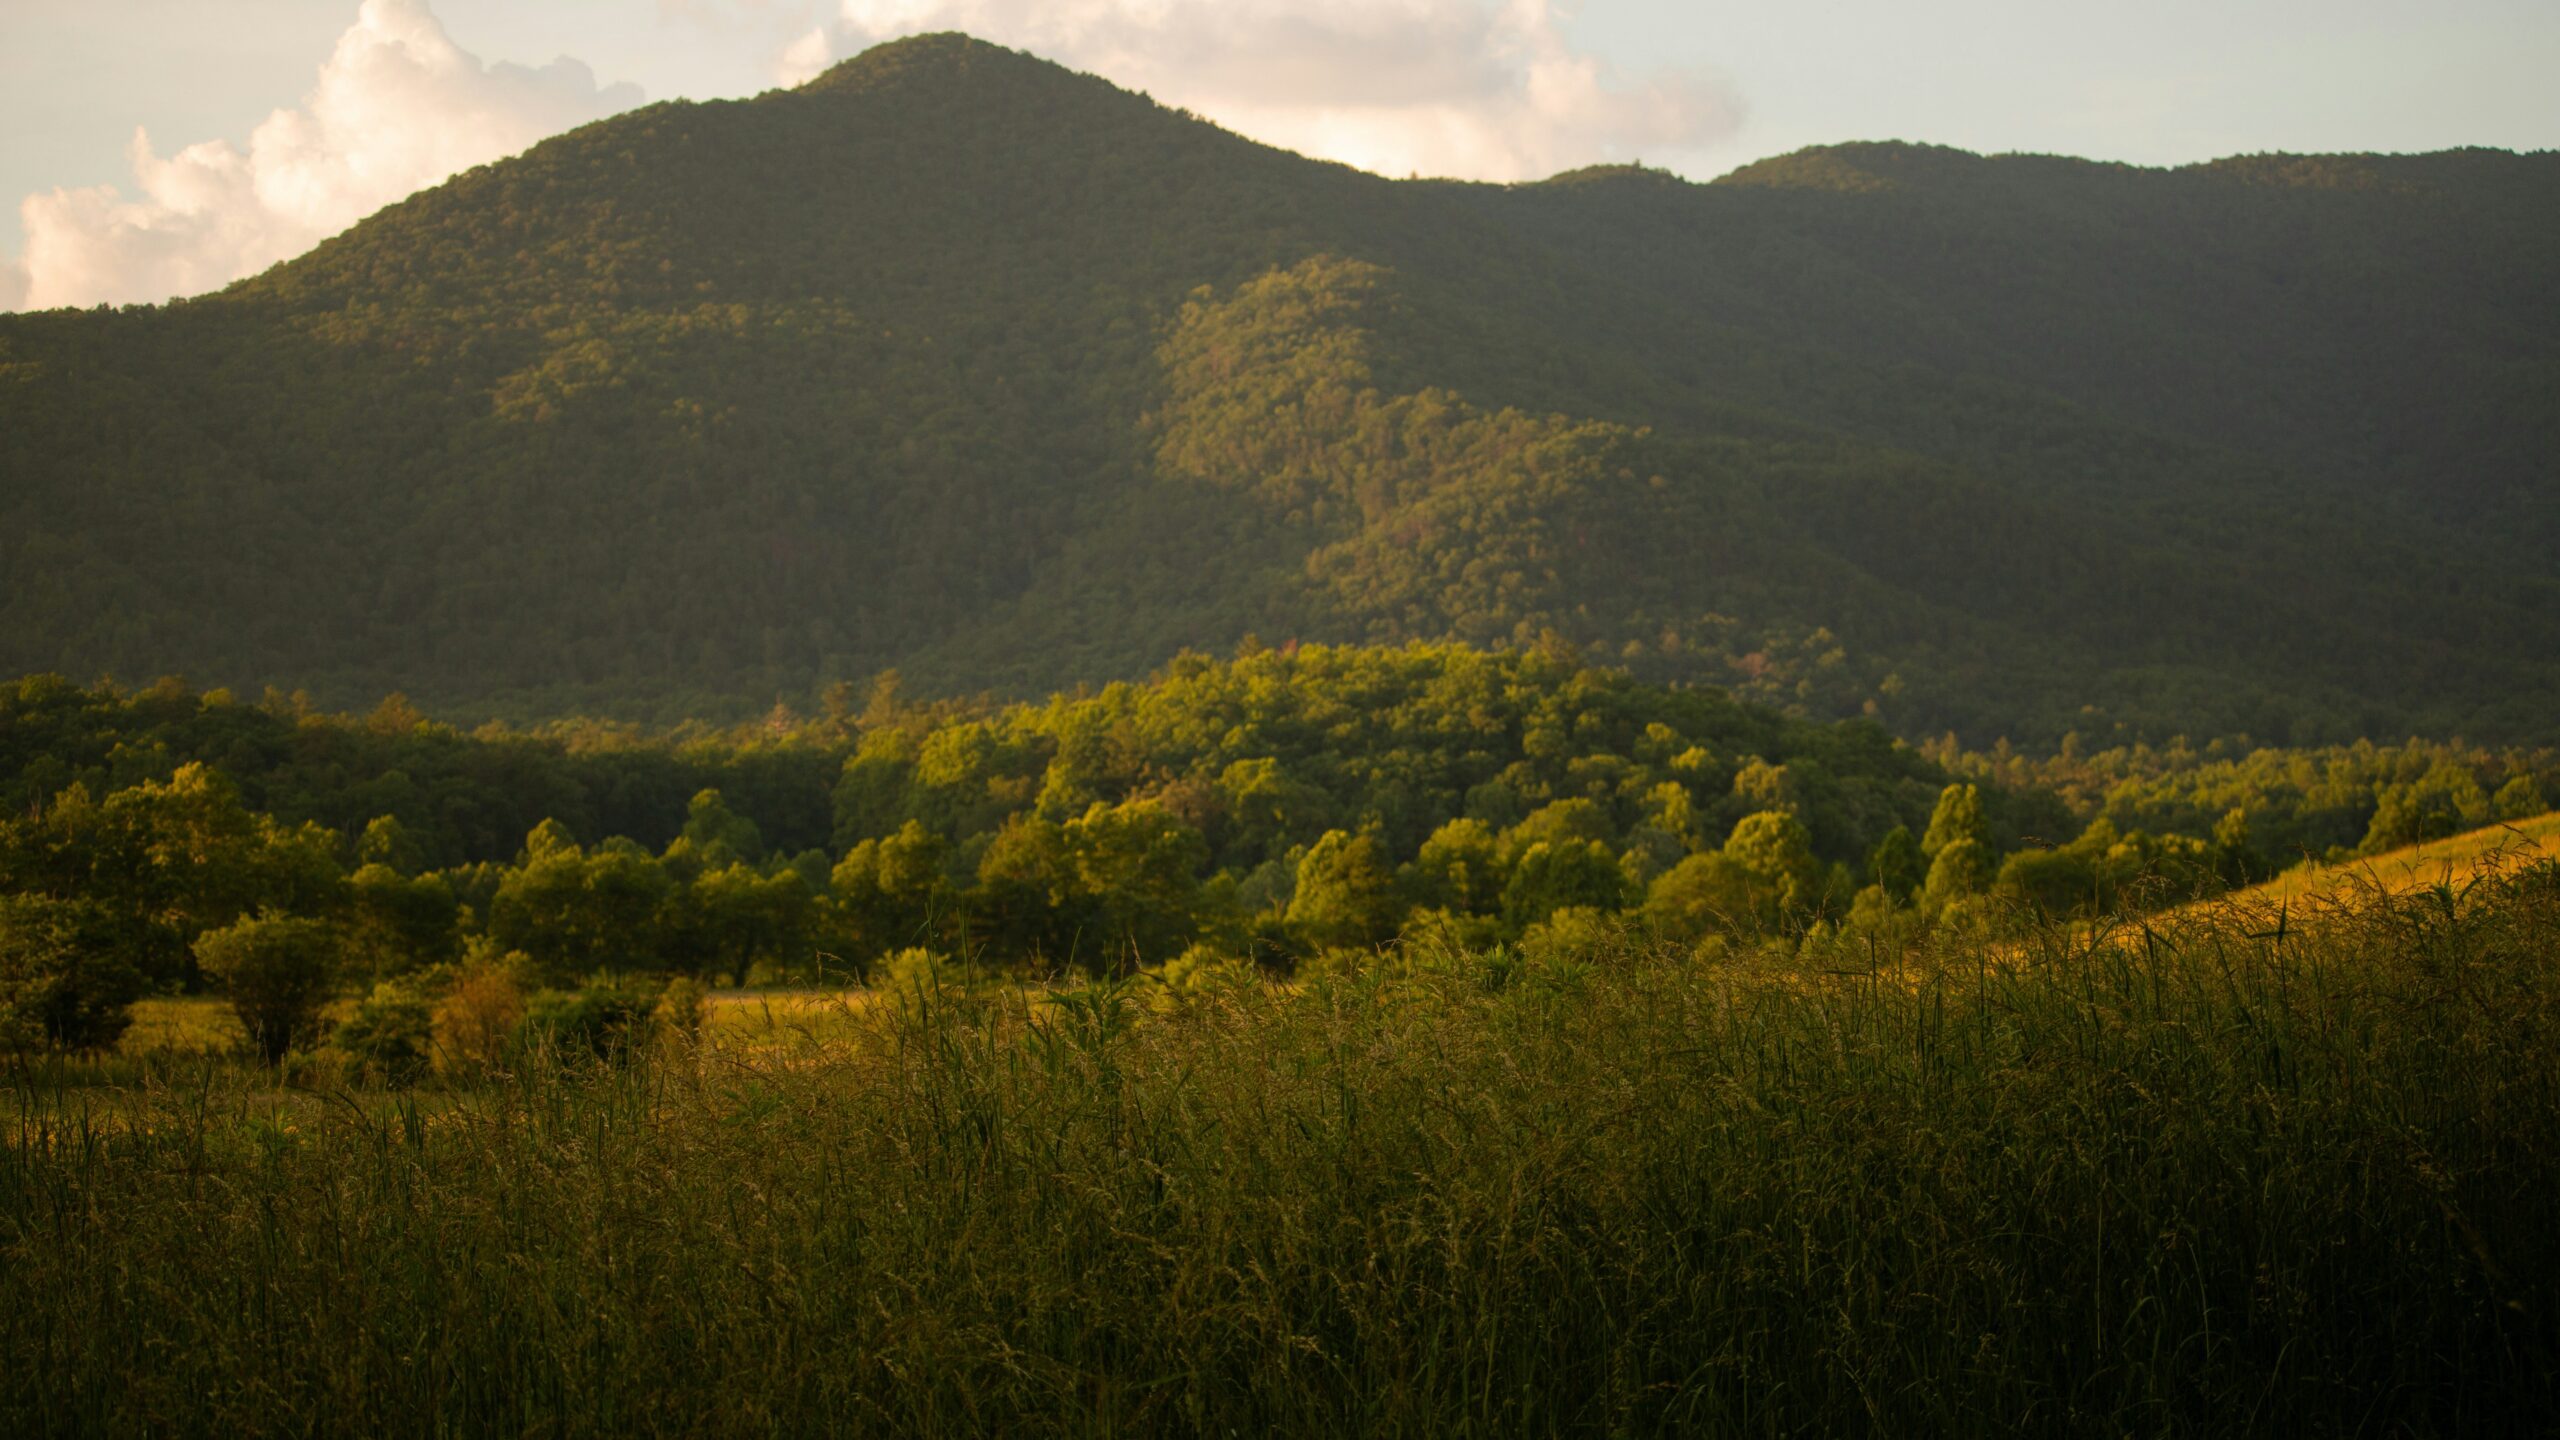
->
(0, 894), (146, 1051)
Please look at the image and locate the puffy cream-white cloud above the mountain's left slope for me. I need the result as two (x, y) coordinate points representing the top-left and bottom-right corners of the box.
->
(0, 0), (640, 307)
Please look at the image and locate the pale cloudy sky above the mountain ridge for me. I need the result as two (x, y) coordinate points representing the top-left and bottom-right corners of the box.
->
(0, 0), (2560, 310)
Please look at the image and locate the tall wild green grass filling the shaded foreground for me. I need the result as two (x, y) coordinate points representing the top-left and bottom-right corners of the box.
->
(15, 866), (2560, 1435)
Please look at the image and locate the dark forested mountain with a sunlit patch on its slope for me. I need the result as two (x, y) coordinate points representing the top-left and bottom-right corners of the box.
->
(0, 36), (2560, 740)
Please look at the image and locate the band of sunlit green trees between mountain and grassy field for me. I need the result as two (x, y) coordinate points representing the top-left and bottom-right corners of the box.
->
(0, 646), (2560, 1009)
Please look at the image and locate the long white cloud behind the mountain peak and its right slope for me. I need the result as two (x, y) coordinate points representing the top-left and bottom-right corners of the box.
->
(840, 0), (1741, 179)
